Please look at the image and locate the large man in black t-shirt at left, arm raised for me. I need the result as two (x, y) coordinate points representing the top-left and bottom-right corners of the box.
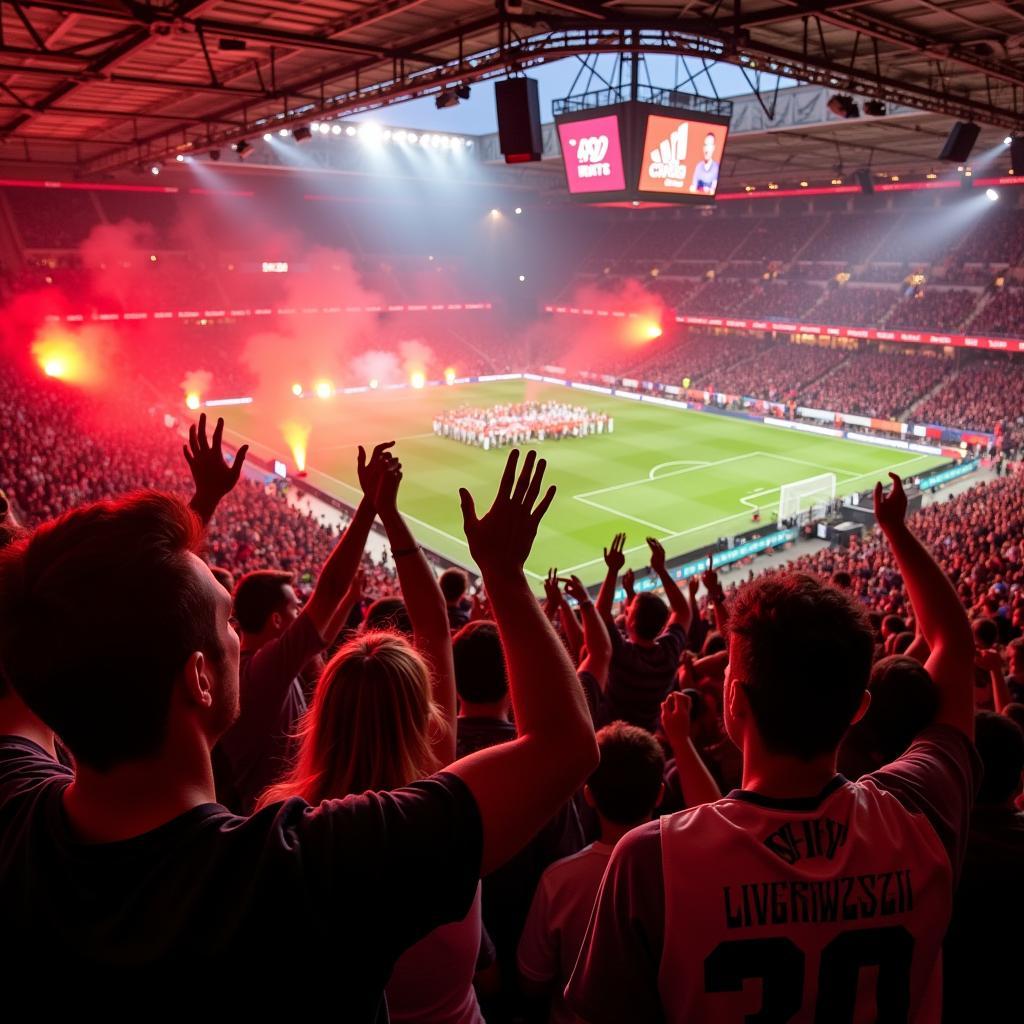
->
(0, 444), (597, 1007)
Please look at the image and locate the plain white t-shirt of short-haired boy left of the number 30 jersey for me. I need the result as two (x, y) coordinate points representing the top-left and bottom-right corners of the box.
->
(518, 843), (613, 1024)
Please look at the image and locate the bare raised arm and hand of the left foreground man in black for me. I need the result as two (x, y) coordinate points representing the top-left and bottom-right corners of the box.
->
(451, 451), (598, 873)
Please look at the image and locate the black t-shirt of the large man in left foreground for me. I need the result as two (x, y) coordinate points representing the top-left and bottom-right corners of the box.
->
(0, 738), (482, 1021)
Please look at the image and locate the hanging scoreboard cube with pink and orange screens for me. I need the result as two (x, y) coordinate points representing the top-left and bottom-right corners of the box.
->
(555, 102), (729, 206)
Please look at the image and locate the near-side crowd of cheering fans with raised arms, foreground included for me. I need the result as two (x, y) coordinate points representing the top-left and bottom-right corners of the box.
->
(0, 349), (1024, 1024)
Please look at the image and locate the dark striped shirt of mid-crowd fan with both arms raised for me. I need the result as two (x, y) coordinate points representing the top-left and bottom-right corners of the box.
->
(605, 623), (686, 732)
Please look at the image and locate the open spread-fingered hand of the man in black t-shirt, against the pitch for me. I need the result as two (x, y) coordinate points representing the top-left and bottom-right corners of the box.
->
(459, 449), (555, 577)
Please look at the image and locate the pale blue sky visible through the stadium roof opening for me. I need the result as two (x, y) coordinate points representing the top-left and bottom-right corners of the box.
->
(353, 55), (796, 135)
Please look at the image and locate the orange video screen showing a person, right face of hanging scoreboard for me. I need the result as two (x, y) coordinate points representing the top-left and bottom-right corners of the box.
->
(637, 114), (729, 196)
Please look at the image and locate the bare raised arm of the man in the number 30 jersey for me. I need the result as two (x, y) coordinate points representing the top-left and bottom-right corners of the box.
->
(874, 473), (975, 738)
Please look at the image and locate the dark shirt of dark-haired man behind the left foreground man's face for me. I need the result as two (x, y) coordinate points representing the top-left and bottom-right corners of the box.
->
(213, 613), (324, 814)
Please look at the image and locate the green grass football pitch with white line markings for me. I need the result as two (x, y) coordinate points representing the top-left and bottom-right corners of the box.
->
(225, 381), (944, 585)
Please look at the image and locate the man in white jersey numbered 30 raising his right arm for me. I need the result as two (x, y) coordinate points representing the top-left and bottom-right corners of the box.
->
(566, 474), (980, 1024)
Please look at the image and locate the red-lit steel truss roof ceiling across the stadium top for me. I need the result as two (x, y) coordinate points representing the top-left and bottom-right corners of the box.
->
(0, 0), (1024, 174)
